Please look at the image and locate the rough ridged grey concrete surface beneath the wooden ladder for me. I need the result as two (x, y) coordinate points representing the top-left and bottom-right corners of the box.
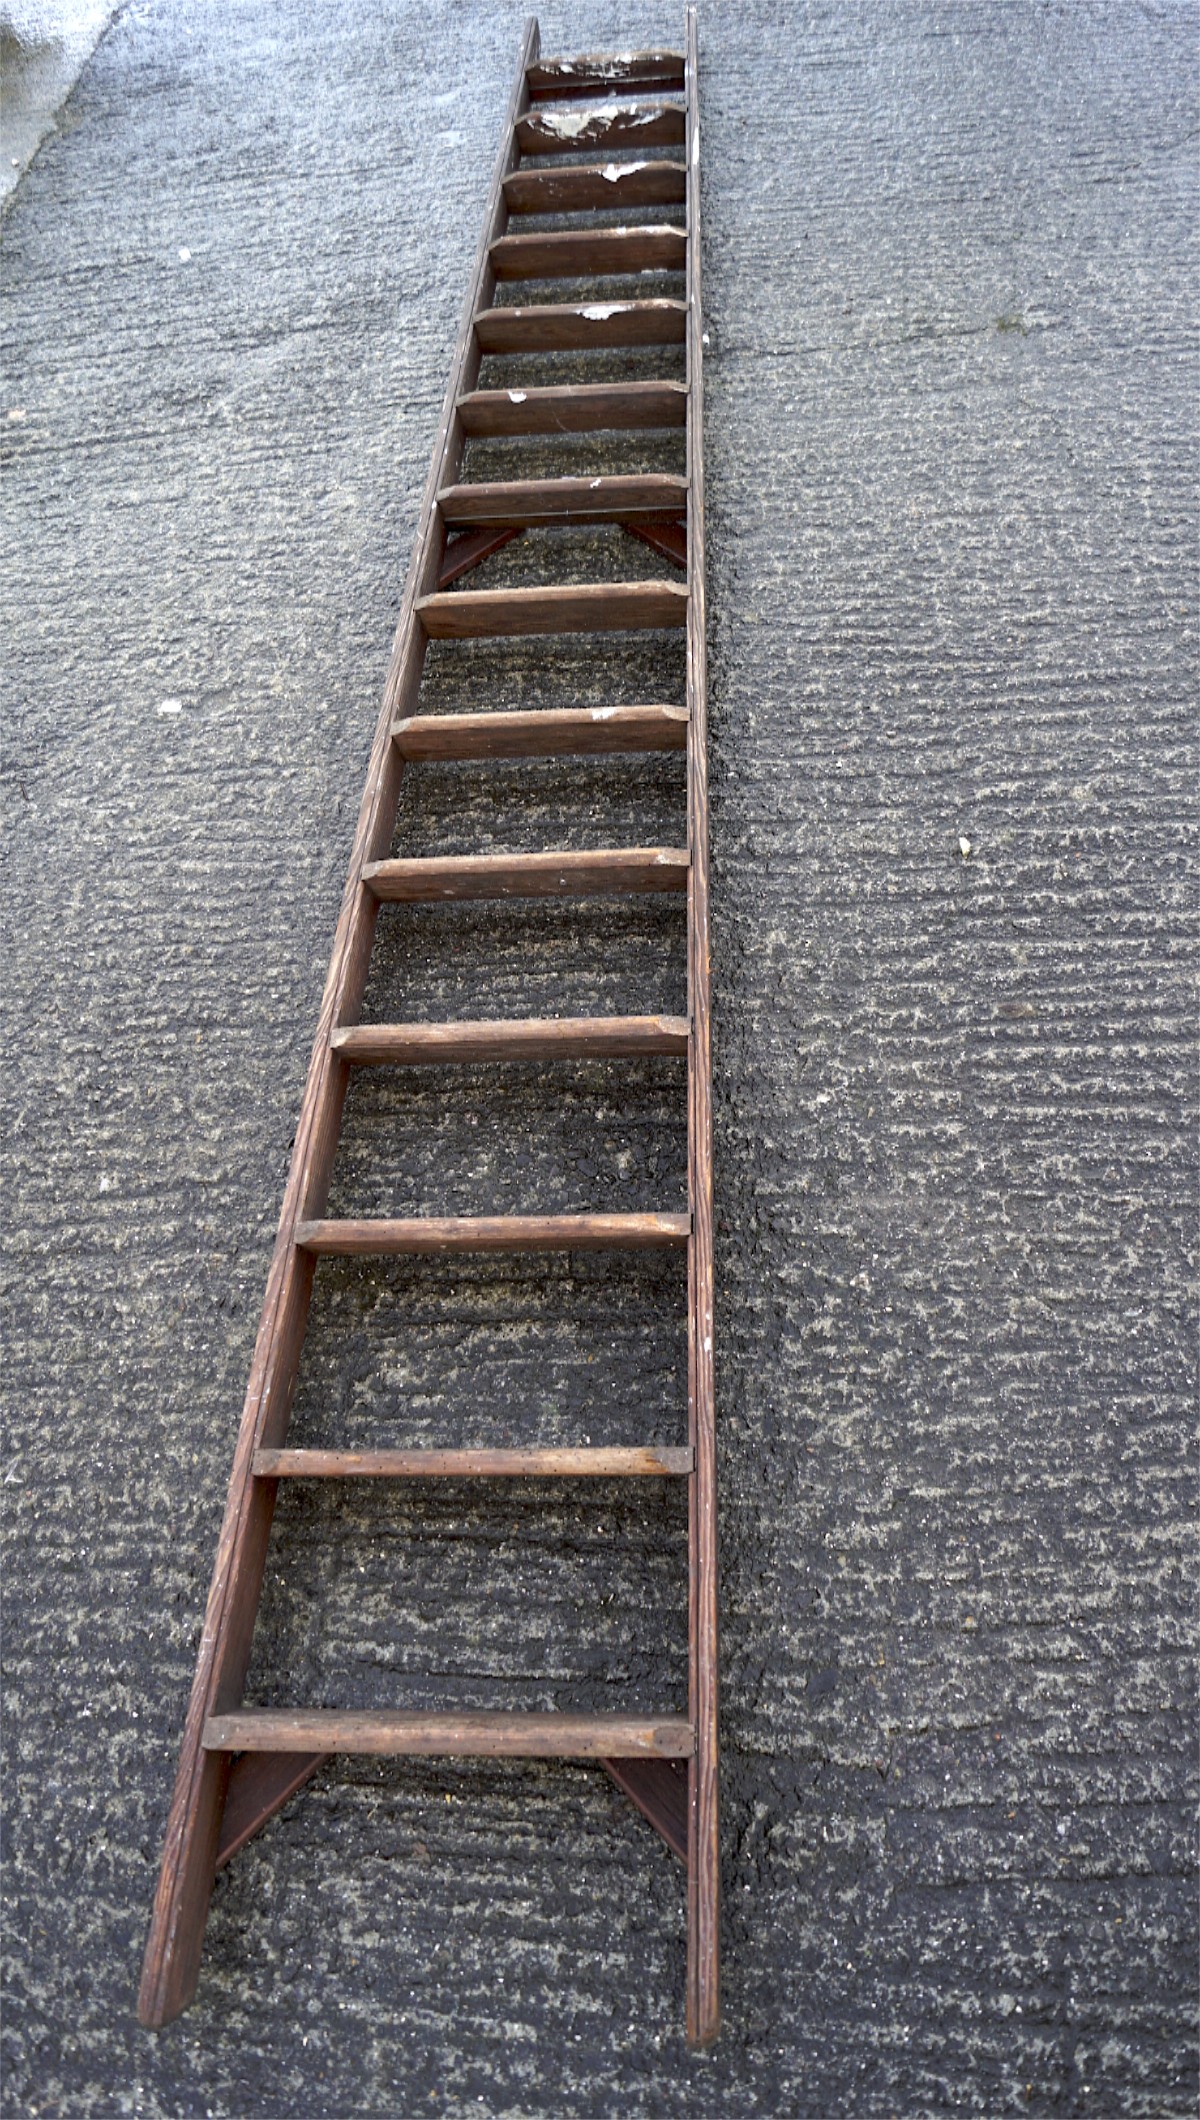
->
(0, 0), (1198, 2120)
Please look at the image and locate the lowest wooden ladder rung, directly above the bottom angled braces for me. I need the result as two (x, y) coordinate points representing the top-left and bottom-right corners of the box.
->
(204, 1709), (693, 1760)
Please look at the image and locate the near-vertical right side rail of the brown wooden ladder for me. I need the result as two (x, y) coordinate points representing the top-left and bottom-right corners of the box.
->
(685, 6), (721, 2046)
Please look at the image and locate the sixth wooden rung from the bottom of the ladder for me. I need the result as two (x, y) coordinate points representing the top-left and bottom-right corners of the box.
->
(392, 706), (687, 759)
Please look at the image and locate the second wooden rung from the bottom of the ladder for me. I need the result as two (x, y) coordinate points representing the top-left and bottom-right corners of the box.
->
(254, 1448), (693, 1480)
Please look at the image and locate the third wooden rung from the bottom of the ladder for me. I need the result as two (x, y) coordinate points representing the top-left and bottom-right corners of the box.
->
(297, 1215), (691, 1259)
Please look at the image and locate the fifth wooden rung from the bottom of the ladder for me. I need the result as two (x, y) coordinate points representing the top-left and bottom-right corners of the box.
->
(363, 846), (687, 905)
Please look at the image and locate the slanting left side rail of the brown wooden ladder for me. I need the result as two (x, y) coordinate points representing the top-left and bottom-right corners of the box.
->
(138, 17), (539, 2027)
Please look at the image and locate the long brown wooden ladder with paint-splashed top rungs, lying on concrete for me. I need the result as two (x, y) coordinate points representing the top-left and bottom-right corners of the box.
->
(138, 8), (719, 2046)
